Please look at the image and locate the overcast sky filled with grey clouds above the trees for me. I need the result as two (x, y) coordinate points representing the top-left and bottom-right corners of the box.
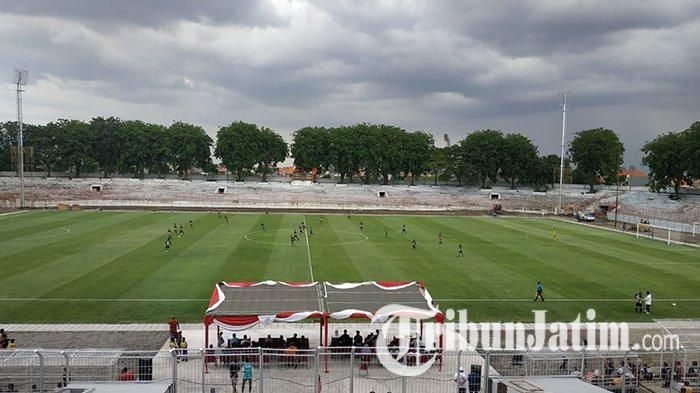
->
(0, 0), (700, 164)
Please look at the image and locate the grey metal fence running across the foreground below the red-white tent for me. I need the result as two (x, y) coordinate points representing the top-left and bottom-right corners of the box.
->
(0, 348), (700, 393)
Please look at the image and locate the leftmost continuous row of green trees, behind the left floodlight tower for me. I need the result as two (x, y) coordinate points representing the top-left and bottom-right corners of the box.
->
(0, 117), (215, 178)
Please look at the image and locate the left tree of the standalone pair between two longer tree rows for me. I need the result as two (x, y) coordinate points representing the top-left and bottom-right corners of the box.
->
(214, 121), (259, 181)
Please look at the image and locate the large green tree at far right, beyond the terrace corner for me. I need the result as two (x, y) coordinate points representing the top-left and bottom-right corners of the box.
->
(642, 132), (693, 199)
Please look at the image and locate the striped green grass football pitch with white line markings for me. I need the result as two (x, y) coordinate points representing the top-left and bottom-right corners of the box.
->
(0, 211), (700, 323)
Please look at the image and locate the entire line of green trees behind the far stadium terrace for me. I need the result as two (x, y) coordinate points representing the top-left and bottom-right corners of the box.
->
(0, 117), (700, 193)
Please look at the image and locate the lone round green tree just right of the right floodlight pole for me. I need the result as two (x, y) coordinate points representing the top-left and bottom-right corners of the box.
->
(569, 128), (625, 192)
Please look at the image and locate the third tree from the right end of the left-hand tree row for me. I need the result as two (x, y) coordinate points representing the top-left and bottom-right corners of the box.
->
(90, 117), (124, 177)
